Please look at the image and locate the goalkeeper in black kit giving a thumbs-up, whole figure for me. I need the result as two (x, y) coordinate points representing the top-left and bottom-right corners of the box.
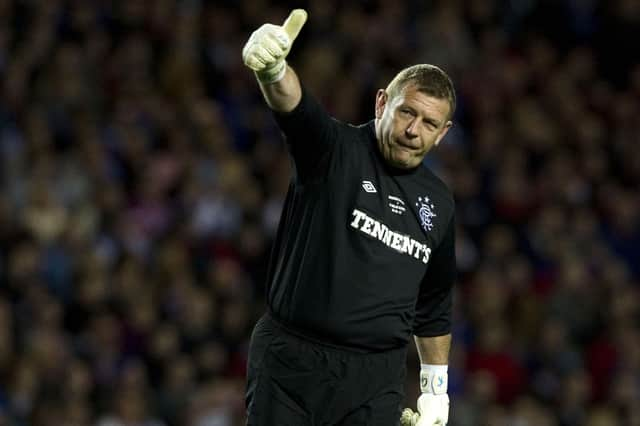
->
(242, 9), (455, 426)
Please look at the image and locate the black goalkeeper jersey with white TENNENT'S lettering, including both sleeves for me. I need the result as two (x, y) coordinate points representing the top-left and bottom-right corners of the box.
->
(267, 89), (455, 352)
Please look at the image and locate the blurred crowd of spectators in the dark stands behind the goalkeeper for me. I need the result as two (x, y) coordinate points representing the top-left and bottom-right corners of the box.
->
(0, 0), (640, 426)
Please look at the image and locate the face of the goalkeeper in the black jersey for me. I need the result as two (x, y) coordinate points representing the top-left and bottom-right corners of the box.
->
(376, 85), (451, 169)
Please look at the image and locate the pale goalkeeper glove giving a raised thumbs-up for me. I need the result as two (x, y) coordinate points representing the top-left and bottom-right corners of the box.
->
(242, 9), (307, 84)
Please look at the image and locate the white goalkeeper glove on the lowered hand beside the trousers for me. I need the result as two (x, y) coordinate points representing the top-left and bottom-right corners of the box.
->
(400, 364), (449, 426)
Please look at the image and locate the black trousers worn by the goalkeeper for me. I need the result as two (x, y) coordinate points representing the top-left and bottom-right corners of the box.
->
(246, 314), (406, 426)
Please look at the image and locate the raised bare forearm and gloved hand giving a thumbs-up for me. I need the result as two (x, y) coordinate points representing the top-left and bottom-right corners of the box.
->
(242, 9), (307, 112)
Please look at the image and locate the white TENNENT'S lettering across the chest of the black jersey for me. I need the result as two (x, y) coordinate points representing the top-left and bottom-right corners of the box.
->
(351, 209), (431, 264)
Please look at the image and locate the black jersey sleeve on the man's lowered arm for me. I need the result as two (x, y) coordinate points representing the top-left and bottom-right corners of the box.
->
(413, 215), (456, 337)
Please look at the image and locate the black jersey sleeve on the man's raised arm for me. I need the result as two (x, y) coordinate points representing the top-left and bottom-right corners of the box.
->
(274, 86), (338, 179)
